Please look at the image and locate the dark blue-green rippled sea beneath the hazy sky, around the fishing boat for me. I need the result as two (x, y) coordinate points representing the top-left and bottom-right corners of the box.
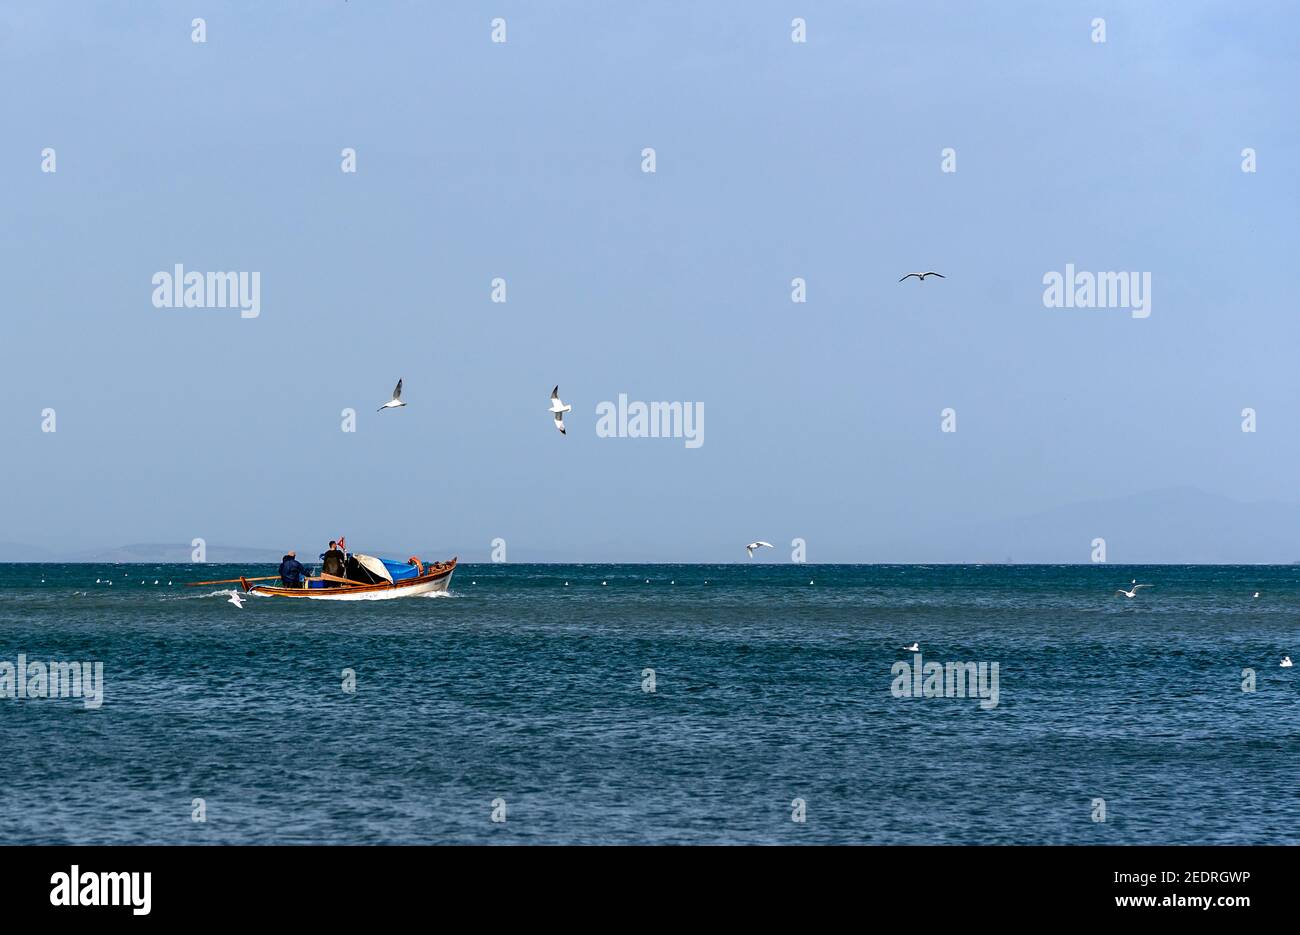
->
(0, 562), (1300, 844)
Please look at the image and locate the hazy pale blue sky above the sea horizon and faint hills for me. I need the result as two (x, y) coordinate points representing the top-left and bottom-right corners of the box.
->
(0, 0), (1300, 562)
